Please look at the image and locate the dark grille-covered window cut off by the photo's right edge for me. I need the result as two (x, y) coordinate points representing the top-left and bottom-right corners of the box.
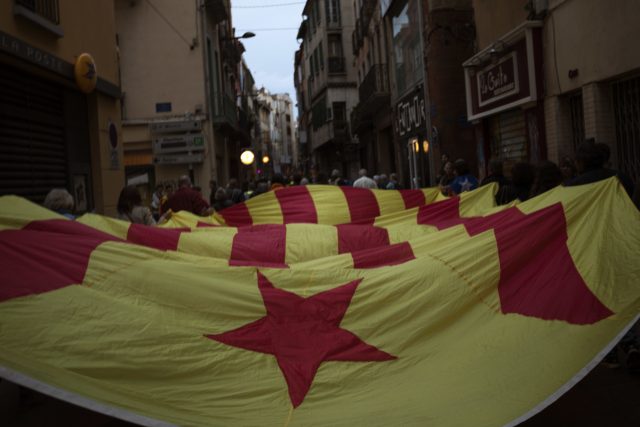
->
(611, 76), (640, 184)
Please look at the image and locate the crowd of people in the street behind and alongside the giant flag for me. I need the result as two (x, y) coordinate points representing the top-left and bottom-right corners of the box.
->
(44, 140), (640, 225)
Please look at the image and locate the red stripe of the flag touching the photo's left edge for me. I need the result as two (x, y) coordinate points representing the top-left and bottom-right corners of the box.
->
(0, 219), (122, 302)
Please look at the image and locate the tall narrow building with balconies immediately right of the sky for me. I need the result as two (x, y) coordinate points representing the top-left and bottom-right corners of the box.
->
(297, 0), (360, 176)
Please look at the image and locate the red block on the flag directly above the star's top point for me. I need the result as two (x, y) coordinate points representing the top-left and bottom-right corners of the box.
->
(229, 225), (287, 267)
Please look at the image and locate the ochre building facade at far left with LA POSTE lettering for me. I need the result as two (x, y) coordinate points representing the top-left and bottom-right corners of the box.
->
(0, 0), (124, 215)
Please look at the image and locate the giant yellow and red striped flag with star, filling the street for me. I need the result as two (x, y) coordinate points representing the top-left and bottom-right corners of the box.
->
(0, 179), (640, 426)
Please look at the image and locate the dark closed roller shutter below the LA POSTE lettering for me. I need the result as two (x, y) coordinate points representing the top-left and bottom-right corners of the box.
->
(0, 64), (68, 203)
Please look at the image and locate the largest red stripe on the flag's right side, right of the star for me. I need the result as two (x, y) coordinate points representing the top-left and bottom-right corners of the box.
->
(418, 202), (613, 325)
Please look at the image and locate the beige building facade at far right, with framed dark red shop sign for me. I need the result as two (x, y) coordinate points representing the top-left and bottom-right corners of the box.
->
(465, 0), (640, 183)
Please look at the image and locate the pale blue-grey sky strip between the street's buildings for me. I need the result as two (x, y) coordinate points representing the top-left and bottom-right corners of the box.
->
(231, 0), (305, 111)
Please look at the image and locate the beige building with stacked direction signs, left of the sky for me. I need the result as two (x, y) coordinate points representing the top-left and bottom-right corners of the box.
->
(115, 0), (254, 198)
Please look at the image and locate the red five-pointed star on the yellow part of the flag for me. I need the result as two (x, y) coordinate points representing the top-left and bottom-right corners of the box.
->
(207, 272), (396, 407)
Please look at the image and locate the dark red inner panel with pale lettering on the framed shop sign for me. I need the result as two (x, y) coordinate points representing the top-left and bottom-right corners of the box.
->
(476, 51), (520, 107)
